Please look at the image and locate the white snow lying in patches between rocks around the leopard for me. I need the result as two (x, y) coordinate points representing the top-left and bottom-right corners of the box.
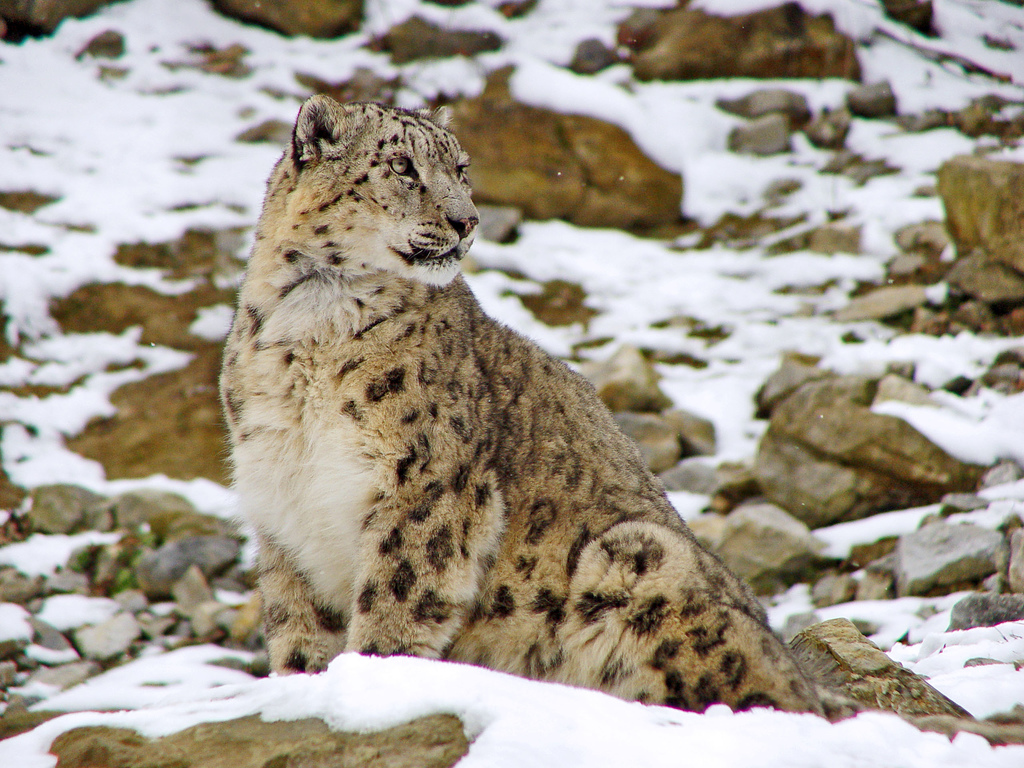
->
(0, 0), (1024, 768)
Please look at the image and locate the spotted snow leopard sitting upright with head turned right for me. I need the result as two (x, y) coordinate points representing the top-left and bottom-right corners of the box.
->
(220, 95), (822, 714)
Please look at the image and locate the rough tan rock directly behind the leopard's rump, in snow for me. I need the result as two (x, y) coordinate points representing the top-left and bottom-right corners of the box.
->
(790, 618), (970, 718)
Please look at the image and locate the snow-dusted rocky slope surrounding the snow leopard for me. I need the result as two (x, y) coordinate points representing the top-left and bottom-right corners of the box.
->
(0, 0), (1024, 768)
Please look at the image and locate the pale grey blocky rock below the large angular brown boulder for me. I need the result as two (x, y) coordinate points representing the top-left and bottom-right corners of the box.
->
(895, 522), (1002, 597)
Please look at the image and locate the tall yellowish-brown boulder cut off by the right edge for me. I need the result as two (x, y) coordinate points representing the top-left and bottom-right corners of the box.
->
(938, 155), (1024, 272)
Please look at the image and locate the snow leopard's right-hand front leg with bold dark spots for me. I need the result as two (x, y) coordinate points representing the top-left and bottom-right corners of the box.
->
(345, 464), (504, 658)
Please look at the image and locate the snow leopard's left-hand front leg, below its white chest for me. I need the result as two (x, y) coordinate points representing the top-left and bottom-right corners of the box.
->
(257, 536), (348, 674)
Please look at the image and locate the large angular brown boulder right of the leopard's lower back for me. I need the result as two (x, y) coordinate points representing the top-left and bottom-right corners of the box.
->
(754, 375), (982, 528)
